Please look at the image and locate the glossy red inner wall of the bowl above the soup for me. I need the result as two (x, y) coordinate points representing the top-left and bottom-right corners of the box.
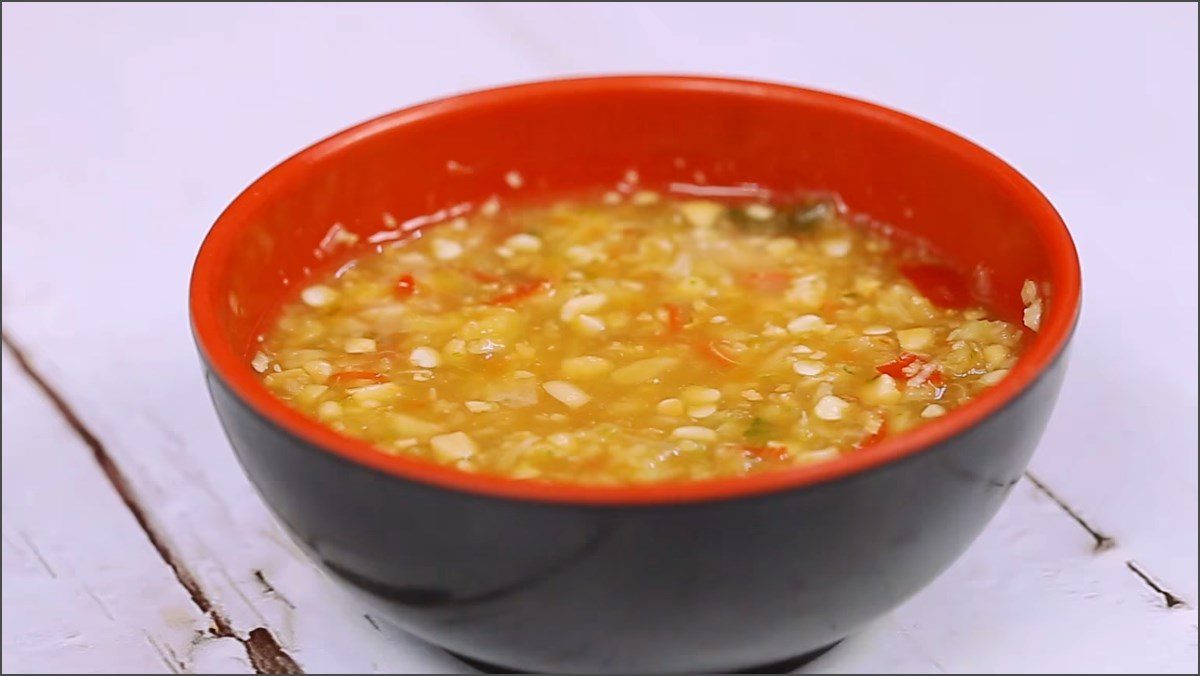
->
(192, 77), (1079, 504)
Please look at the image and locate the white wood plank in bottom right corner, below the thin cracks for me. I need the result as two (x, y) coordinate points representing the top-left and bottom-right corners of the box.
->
(873, 480), (1196, 674)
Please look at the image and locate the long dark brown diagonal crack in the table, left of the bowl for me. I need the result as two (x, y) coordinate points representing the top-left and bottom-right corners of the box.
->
(0, 330), (304, 674)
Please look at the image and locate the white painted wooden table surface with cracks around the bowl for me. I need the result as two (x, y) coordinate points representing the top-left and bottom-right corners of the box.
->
(2, 5), (1200, 672)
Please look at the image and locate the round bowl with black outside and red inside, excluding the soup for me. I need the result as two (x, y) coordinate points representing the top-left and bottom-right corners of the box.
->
(191, 77), (1080, 672)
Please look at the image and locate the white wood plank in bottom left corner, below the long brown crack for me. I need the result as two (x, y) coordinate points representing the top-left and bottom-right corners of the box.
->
(2, 349), (251, 672)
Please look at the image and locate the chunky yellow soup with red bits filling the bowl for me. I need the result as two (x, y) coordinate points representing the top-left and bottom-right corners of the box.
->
(251, 191), (1040, 484)
